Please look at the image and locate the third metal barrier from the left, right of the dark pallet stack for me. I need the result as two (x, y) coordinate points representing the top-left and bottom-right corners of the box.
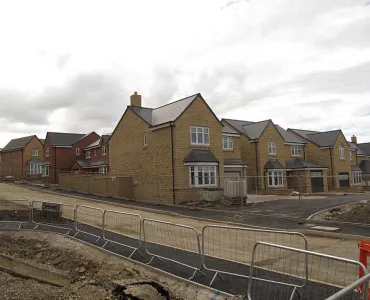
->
(74, 205), (104, 241)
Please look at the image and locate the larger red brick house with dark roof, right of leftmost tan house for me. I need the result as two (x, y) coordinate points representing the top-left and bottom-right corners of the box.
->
(43, 132), (100, 183)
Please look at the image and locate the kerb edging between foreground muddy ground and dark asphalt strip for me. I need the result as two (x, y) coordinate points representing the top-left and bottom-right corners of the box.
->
(0, 228), (234, 299)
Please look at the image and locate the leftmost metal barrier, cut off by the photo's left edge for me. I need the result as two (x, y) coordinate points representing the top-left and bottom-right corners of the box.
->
(0, 199), (31, 227)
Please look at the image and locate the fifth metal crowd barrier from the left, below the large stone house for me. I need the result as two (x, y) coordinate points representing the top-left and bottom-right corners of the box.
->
(143, 219), (203, 279)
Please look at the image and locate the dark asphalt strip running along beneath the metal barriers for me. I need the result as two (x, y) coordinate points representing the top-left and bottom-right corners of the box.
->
(0, 222), (360, 300)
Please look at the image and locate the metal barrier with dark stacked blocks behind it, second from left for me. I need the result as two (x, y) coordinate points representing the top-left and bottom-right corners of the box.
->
(32, 201), (76, 234)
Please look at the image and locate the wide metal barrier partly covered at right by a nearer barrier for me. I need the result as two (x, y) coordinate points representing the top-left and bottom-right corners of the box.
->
(202, 225), (308, 285)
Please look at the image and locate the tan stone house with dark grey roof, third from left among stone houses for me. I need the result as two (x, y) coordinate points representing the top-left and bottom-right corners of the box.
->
(288, 129), (362, 190)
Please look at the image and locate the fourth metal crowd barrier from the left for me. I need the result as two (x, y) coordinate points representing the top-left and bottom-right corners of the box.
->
(102, 210), (142, 257)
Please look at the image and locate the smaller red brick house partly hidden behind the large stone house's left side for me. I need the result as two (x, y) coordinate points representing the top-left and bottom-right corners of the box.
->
(72, 135), (110, 174)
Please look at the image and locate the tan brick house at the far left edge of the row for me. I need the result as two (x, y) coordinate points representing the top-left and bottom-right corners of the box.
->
(0, 135), (43, 179)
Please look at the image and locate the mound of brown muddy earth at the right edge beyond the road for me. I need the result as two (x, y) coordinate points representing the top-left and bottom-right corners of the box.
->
(318, 202), (370, 224)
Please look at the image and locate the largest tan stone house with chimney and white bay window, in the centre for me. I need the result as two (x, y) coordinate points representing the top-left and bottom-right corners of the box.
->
(109, 92), (225, 204)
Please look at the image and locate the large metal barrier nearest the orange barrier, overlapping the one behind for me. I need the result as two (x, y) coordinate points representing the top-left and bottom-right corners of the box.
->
(248, 242), (367, 300)
